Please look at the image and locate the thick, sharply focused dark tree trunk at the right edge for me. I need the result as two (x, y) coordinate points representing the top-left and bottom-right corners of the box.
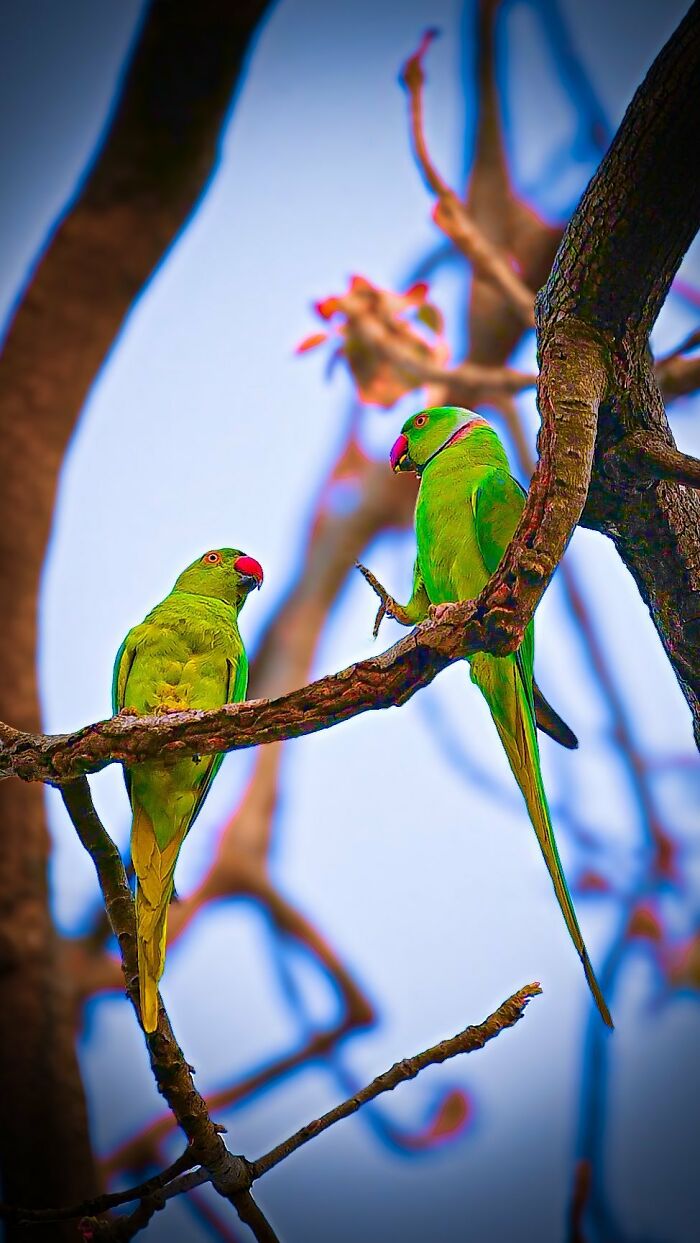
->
(537, 2), (700, 746)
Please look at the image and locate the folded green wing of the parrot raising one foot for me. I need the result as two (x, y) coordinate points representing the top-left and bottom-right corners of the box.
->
(471, 470), (578, 751)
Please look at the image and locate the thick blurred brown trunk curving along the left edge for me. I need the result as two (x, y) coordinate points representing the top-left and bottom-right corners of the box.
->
(0, 0), (265, 1223)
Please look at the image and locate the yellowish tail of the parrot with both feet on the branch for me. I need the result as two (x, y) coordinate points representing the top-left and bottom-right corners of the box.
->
(132, 798), (180, 1032)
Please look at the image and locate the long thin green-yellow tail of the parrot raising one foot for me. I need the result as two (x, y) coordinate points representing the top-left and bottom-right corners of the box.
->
(472, 656), (613, 1028)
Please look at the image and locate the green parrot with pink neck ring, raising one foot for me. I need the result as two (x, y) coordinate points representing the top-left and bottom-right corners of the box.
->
(368, 405), (613, 1027)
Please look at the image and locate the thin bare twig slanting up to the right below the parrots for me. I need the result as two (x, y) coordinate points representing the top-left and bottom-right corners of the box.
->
(251, 983), (542, 1178)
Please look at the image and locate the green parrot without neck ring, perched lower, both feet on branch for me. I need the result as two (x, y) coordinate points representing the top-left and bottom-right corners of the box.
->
(112, 548), (262, 1032)
